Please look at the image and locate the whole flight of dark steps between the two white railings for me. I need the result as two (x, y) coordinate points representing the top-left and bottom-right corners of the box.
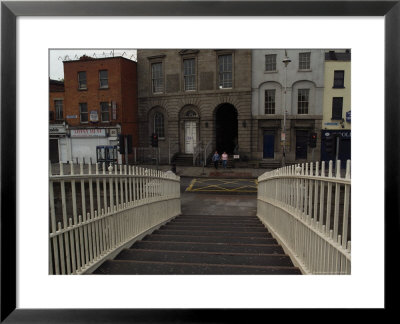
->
(93, 215), (301, 275)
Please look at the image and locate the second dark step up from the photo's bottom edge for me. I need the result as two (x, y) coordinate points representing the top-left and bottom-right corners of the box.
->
(114, 249), (293, 267)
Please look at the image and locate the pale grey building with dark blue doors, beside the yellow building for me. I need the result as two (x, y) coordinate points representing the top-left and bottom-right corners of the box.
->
(252, 49), (325, 167)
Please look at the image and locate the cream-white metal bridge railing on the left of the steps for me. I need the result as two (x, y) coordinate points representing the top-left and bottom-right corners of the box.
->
(49, 163), (181, 274)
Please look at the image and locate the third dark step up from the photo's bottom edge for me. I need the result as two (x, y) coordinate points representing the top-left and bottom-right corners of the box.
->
(131, 240), (284, 254)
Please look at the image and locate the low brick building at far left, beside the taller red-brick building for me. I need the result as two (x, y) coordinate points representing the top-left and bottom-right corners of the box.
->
(49, 79), (66, 163)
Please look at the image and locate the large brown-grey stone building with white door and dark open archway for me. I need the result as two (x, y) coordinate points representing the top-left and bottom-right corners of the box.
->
(137, 49), (251, 161)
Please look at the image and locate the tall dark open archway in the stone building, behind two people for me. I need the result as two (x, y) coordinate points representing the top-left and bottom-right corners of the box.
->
(215, 103), (238, 154)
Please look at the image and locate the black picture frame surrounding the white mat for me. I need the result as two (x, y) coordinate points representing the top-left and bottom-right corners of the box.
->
(0, 0), (400, 323)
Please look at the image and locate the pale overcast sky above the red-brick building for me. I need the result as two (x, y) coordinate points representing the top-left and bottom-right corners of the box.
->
(49, 48), (136, 80)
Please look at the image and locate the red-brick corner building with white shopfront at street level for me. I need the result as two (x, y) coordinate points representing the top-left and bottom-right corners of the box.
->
(58, 56), (139, 163)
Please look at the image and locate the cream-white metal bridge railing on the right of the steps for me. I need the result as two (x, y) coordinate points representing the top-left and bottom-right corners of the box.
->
(257, 160), (351, 274)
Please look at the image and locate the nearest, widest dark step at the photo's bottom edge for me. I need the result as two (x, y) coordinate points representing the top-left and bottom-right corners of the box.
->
(93, 260), (301, 275)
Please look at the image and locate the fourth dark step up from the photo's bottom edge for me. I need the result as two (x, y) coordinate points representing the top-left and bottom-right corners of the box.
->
(143, 234), (276, 244)
